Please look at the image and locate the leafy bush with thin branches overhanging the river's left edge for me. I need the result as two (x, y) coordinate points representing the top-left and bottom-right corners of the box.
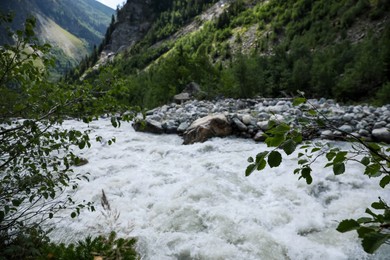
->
(0, 16), (137, 258)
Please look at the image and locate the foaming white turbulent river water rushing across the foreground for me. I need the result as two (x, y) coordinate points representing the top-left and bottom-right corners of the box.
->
(52, 120), (390, 260)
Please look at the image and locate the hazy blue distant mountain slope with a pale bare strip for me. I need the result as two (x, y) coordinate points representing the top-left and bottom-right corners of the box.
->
(0, 0), (114, 77)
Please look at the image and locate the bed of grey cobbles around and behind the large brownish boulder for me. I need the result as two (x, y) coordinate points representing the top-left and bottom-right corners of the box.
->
(139, 98), (390, 143)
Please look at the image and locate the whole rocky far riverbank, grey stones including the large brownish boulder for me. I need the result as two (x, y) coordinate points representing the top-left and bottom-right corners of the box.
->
(133, 98), (390, 144)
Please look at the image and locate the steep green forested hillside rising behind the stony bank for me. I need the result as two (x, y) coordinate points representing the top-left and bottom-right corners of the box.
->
(72, 0), (390, 107)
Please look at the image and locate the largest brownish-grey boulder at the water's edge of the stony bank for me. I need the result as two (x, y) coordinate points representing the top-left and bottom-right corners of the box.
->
(183, 114), (232, 144)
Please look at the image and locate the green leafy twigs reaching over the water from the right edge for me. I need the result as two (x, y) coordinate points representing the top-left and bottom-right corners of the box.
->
(245, 98), (390, 253)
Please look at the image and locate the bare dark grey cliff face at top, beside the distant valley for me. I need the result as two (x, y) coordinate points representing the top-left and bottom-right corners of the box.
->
(105, 0), (155, 52)
